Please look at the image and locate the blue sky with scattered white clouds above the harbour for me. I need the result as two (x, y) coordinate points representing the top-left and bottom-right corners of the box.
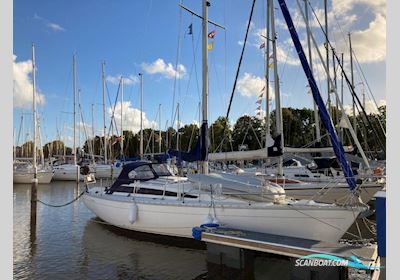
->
(13, 0), (386, 148)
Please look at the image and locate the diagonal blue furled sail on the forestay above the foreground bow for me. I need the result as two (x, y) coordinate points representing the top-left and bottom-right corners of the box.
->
(278, 0), (356, 191)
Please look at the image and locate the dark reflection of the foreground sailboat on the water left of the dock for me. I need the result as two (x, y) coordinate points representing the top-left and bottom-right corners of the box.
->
(81, 219), (206, 279)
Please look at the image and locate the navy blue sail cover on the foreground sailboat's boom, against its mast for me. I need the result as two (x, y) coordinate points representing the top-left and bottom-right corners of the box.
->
(168, 122), (208, 162)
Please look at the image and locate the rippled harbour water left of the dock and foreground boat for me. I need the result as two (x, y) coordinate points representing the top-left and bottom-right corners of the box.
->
(13, 182), (207, 279)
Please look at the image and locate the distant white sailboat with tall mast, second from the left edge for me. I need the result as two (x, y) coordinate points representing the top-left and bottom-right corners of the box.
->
(53, 55), (83, 181)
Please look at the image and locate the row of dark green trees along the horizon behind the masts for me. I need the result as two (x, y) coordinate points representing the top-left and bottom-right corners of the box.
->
(15, 106), (386, 160)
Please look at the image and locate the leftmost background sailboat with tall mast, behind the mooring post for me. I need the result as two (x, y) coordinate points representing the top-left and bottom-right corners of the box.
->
(13, 45), (53, 184)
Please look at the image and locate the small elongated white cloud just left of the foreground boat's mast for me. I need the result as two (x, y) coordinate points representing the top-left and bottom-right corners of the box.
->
(142, 58), (186, 79)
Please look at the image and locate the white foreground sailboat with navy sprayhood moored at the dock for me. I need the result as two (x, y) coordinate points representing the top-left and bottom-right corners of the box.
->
(83, 0), (368, 242)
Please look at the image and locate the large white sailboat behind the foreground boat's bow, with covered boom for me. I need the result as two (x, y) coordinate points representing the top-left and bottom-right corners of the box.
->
(209, 1), (384, 203)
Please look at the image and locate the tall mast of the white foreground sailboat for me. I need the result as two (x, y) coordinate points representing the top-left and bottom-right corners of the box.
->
(200, 0), (210, 174)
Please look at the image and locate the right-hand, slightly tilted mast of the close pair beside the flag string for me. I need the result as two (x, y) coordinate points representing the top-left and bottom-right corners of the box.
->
(268, 0), (284, 177)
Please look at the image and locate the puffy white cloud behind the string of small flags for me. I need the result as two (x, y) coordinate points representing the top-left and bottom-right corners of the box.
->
(237, 72), (275, 98)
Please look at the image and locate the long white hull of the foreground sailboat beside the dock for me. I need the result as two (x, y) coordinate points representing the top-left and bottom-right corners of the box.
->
(83, 188), (364, 242)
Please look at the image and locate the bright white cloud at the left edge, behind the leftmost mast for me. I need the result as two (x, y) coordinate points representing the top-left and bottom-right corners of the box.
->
(13, 55), (46, 108)
